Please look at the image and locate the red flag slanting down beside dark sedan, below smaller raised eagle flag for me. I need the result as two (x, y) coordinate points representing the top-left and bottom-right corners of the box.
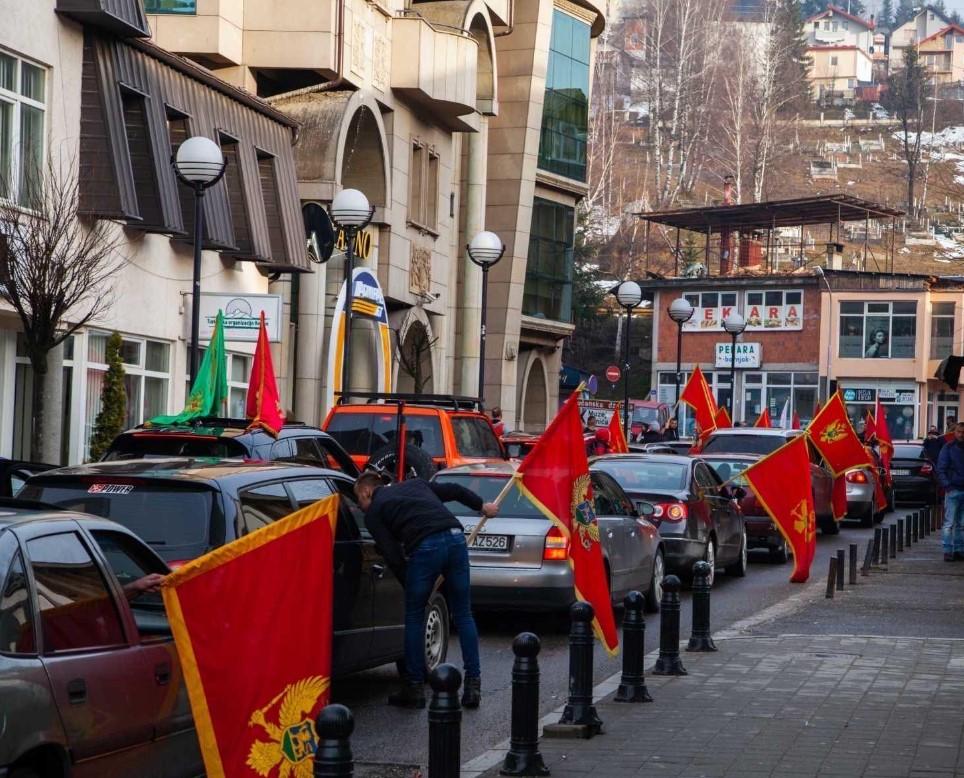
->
(743, 435), (817, 583)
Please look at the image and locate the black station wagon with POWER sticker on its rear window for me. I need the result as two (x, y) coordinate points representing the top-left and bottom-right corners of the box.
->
(20, 459), (449, 675)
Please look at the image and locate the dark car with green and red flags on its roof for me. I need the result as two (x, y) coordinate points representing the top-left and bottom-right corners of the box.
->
(101, 418), (358, 478)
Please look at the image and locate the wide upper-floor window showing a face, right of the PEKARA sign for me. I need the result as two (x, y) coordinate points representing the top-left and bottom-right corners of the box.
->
(839, 302), (917, 359)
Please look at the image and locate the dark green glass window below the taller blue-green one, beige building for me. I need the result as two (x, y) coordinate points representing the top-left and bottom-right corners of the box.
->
(522, 197), (575, 322)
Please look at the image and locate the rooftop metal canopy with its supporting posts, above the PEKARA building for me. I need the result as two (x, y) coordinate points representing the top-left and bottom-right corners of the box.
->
(634, 194), (904, 276)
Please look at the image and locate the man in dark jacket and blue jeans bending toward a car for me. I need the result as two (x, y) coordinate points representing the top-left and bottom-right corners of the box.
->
(355, 473), (499, 708)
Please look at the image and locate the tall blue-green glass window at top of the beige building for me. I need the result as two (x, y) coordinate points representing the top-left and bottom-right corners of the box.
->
(539, 9), (590, 181)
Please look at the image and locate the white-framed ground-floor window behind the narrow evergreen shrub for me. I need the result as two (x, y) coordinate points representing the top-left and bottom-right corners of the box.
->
(84, 332), (171, 459)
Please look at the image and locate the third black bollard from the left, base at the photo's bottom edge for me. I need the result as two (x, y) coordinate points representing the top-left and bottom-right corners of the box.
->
(499, 632), (549, 775)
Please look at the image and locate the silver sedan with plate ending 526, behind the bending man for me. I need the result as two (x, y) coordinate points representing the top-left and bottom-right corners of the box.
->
(434, 462), (664, 612)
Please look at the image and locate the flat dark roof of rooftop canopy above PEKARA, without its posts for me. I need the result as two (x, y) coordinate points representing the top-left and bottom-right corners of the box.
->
(634, 194), (904, 234)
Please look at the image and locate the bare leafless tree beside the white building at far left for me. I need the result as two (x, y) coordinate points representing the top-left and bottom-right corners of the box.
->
(0, 159), (121, 460)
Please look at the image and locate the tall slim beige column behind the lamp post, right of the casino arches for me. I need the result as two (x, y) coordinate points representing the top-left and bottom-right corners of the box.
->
(456, 115), (489, 397)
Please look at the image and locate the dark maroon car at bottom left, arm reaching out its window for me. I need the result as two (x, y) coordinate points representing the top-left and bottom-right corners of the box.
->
(0, 500), (204, 778)
